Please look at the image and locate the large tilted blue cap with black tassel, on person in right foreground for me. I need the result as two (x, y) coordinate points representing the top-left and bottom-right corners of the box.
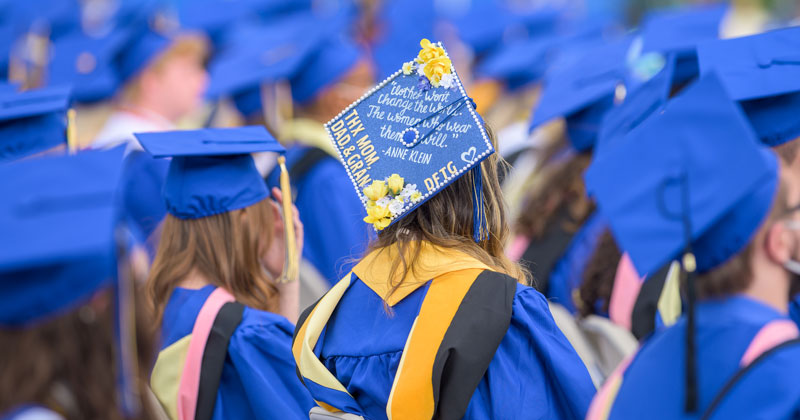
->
(586, 74), (778, 273)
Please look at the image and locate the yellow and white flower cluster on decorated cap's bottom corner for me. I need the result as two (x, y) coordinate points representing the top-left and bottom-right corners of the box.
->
(363, 174), (422, 231)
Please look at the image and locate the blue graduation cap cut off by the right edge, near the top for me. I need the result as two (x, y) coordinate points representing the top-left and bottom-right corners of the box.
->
(698, 27), (800, 146)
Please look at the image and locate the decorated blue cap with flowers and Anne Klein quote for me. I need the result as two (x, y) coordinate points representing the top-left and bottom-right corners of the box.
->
(325, 39), (494, 240)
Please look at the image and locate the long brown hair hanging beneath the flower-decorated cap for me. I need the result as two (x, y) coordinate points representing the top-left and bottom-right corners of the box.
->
(368, 126), (530, 298)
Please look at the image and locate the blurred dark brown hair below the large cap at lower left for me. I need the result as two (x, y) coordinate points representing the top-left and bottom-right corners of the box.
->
(0, 290), (155, 420)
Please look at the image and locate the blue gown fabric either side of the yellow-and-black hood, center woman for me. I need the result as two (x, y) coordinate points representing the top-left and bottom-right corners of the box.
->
(316, 278), (595, 420)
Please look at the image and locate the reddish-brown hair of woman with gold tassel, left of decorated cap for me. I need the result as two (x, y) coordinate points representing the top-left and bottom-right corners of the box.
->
(147, 200), (278, 325)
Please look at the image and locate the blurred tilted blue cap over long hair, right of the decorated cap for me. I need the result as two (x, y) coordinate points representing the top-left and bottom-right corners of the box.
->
(530, 37), (631, 151)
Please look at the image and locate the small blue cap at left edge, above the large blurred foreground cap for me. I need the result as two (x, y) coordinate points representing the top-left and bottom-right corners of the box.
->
(0, 87), (70, 163)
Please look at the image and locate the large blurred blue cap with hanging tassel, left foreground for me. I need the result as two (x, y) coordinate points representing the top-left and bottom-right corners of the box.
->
(0, 148), (139, 417)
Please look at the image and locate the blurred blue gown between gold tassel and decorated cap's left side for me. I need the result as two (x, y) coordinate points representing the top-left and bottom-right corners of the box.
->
(267, 145), (374, 285)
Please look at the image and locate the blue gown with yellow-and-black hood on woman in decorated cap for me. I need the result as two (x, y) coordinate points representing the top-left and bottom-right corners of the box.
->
(293, 244), (595, 420)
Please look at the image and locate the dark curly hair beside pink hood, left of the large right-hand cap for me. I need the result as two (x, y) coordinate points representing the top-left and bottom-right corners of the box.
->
(576, 229), (622, 317)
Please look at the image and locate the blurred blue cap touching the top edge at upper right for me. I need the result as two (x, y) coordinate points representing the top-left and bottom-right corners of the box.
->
(641, 3), (728, 84)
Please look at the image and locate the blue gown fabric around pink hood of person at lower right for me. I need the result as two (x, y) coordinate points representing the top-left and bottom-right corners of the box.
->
(609, 296), (800, 420)
